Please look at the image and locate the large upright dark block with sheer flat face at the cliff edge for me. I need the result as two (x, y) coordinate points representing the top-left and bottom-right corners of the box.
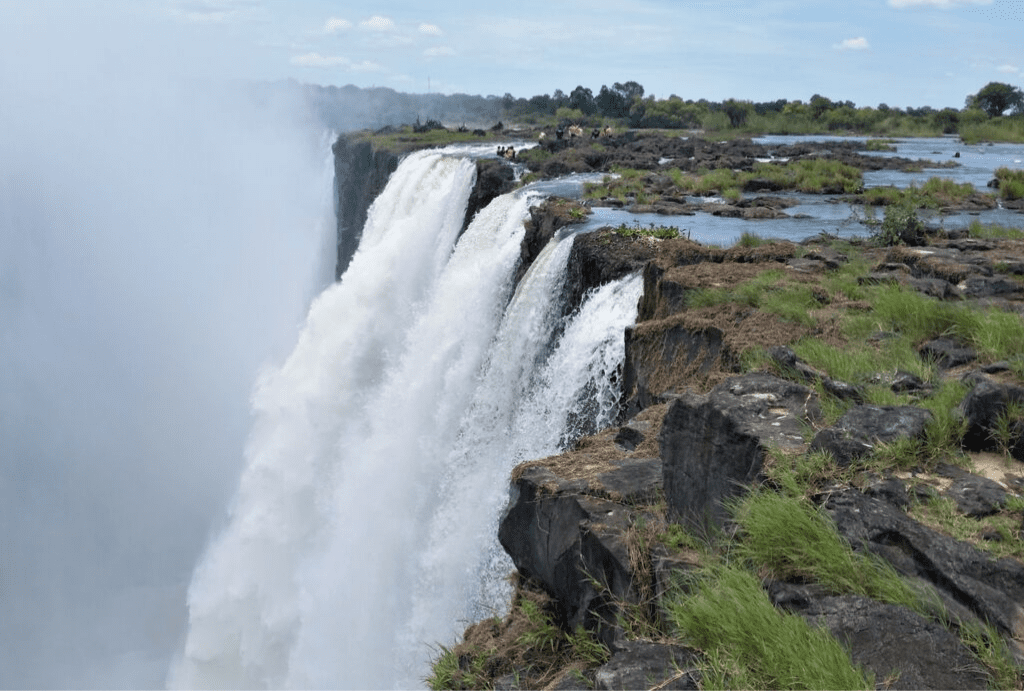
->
(658, 374), (820, 527)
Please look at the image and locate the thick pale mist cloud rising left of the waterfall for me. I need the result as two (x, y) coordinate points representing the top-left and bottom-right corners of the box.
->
(0, 3), (333, 688)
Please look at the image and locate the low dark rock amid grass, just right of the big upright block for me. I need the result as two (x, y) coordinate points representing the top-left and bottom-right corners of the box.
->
(811, 405), (933, 466)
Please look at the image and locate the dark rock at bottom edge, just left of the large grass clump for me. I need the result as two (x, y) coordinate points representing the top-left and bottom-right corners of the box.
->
(594, 641), (700, 691)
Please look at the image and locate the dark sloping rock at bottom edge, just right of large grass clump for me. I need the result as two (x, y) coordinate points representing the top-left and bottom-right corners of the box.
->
(769, 584), (988, 689)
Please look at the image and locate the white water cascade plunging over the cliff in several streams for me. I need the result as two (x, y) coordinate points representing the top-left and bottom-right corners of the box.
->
(169, 146), (640, 688)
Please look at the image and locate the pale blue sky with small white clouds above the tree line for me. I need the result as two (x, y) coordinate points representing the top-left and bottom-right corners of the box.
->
(49, 0), (1024, 109)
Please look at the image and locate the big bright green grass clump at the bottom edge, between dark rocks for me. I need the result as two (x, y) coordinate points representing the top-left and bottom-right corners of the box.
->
(666, 565), (873, 689)
